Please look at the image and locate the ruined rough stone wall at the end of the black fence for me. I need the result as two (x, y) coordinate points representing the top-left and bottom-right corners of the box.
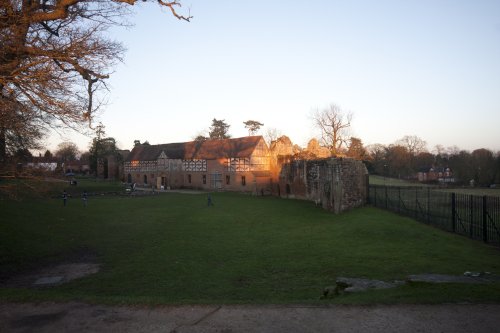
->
(278, 158), (368, 213)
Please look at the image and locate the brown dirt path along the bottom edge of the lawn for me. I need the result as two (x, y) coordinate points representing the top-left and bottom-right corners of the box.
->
(0, 303), (500, 333)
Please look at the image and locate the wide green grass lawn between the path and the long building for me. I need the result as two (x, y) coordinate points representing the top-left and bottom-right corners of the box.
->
(0, 189), (500, 304)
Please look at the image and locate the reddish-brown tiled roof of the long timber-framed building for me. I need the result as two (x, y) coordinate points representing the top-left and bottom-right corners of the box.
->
(125, 136), (262, 162)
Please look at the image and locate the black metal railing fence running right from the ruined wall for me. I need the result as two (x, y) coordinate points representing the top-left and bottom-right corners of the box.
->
(369, 185), (500, 246)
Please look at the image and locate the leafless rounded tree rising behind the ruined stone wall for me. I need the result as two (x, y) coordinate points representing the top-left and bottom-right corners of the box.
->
(312, 104), (352, 155)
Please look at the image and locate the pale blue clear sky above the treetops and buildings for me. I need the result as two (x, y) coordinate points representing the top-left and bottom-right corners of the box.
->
(46, 0), (500, 151)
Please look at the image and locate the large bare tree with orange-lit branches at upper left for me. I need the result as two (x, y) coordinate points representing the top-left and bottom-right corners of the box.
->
(0, 0), (191, 158)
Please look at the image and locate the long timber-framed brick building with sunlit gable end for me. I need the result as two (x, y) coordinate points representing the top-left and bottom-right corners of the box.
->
(124, 136), (271, 192)
